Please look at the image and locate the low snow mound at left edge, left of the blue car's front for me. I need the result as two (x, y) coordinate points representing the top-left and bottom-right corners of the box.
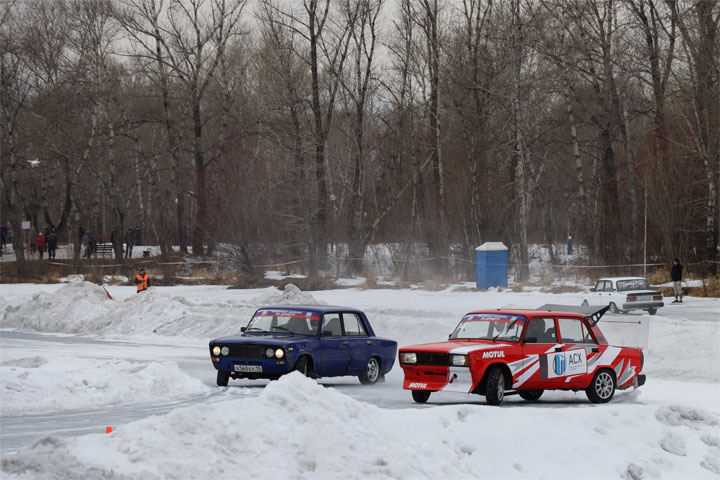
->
(0, 355), (213, 415)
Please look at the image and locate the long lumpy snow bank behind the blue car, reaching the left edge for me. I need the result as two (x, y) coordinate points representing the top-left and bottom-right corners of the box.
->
(0, 282), (324, 338)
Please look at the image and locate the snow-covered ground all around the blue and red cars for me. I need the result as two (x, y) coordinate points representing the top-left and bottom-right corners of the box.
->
(0, 282), (720, 479)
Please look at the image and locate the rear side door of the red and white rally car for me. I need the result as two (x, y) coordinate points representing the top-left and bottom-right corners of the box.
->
(557, 317), (600, 388)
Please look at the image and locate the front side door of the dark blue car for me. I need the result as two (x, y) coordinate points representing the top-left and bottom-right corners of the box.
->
(314, 312), (350, 377)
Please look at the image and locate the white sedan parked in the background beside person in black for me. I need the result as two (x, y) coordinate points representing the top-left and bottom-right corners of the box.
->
(582, 277), (665, 315)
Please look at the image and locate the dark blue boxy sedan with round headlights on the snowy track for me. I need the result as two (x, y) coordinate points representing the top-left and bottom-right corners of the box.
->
(210, 306), (397, 387)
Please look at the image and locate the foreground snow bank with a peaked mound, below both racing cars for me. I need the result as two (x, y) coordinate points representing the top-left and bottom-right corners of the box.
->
(2, 373), (720, 480)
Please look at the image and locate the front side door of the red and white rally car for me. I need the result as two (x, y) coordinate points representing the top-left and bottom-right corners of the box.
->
(518, 317), (564, 390)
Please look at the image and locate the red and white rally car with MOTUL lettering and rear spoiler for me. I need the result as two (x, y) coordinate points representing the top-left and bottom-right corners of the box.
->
(399, 305), (645, 405)
